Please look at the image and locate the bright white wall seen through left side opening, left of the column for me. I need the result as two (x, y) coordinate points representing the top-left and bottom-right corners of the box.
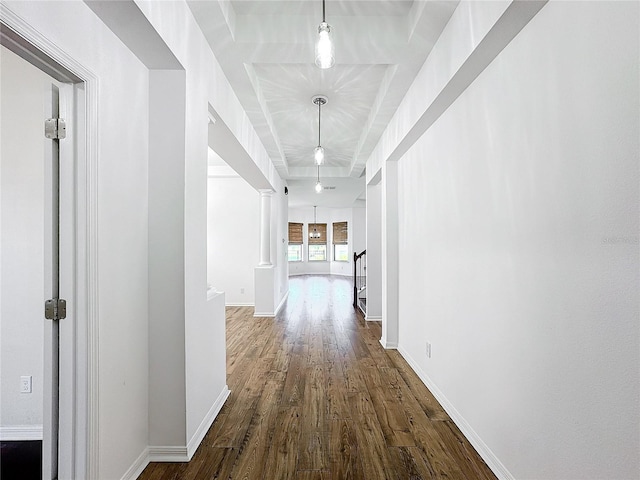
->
(207, 176), (260, 305)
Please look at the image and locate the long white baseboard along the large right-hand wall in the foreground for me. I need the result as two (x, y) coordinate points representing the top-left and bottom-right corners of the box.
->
(398, 346), (515, 480)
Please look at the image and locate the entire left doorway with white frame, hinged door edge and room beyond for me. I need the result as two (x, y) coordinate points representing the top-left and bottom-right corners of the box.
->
(0, 15), (98, 479)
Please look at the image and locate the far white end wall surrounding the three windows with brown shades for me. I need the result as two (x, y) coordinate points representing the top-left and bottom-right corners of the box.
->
(285, 207), (364, 276)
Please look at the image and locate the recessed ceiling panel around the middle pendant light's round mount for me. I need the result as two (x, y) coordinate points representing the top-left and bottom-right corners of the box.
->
(253, 64), (387, 168)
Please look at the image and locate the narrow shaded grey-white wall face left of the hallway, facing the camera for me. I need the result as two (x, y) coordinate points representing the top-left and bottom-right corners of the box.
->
(148, 70), (186, 446)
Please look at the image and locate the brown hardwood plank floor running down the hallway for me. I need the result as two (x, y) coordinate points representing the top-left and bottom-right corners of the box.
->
(139, 275), (496, 480)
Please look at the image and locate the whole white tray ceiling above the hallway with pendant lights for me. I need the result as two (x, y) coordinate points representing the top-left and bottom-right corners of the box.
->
(189, 0), (458, 207)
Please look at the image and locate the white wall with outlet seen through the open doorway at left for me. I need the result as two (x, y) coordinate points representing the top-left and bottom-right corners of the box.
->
(0, 47), (50, 440)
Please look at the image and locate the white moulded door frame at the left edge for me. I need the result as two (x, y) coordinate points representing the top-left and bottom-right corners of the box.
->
(0, 3), (99, 478)
